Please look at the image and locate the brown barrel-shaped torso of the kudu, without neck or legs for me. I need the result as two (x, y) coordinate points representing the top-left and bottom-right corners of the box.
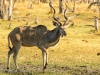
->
(8, 25), (47, 47)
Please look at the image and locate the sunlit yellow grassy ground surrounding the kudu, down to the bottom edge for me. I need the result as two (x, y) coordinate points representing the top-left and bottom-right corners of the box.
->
(0, 2), (100, 75)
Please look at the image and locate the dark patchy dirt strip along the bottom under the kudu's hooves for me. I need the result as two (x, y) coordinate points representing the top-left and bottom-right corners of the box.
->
(0, 63), (100, 75)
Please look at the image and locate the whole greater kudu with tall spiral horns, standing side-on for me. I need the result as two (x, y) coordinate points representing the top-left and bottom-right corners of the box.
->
(7, 3), (76, 70)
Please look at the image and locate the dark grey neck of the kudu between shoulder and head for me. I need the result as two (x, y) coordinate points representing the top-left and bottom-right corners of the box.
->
(46, 28), (60, 44)
